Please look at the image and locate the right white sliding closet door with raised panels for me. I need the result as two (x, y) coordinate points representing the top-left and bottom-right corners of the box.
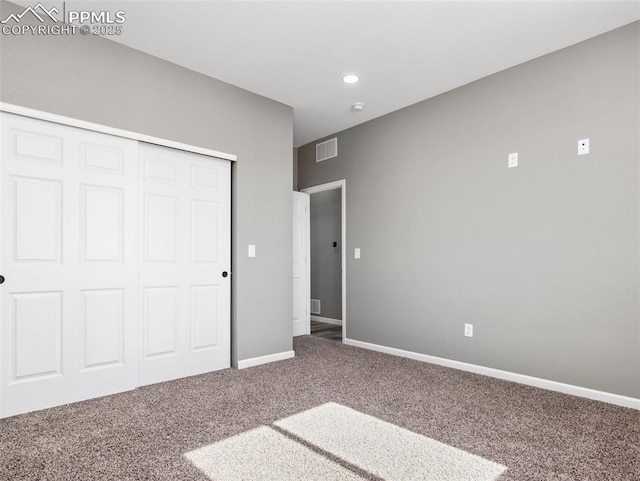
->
(140, 144), (231, 385)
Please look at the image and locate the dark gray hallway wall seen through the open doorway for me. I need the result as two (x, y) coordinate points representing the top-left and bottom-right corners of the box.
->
(309, 189), (342, 320)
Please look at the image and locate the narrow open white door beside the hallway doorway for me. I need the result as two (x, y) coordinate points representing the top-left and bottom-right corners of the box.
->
(293, 192), (311, 337)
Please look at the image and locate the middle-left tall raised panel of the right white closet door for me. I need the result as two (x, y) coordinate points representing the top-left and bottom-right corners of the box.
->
(144, 194), (178, 262)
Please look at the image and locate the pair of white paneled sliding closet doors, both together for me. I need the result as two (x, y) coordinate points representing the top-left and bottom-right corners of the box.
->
(0, 113), (230, 417)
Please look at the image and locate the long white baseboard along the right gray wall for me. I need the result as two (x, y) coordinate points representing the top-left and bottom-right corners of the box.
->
(344, 339), (640, 410)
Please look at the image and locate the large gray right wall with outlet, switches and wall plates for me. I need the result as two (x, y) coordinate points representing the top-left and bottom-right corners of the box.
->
(298, 22), (640, 398)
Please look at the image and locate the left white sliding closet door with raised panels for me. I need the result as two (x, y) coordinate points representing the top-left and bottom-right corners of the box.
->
(0, 114), (138, 416)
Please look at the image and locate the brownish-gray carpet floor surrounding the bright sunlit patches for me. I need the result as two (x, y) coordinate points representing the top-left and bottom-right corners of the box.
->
(0, 336), (640, 481)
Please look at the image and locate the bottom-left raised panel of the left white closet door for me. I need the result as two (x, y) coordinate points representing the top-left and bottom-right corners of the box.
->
(11, 291), (62, 381)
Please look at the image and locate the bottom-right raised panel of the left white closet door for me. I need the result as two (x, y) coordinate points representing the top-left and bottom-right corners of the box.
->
(81, 289), (124, 369)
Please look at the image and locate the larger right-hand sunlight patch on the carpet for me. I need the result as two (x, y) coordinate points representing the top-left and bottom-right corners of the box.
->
(274, 403), (507, 481)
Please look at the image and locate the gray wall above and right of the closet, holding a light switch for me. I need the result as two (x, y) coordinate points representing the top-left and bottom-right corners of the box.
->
(0, 0), (293, 362)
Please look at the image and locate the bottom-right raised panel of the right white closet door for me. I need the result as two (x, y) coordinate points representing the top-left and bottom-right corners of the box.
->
(191, 286), (219, 351)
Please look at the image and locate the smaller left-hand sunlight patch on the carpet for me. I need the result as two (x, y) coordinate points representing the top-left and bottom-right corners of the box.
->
(184, 426), (363, 481)
